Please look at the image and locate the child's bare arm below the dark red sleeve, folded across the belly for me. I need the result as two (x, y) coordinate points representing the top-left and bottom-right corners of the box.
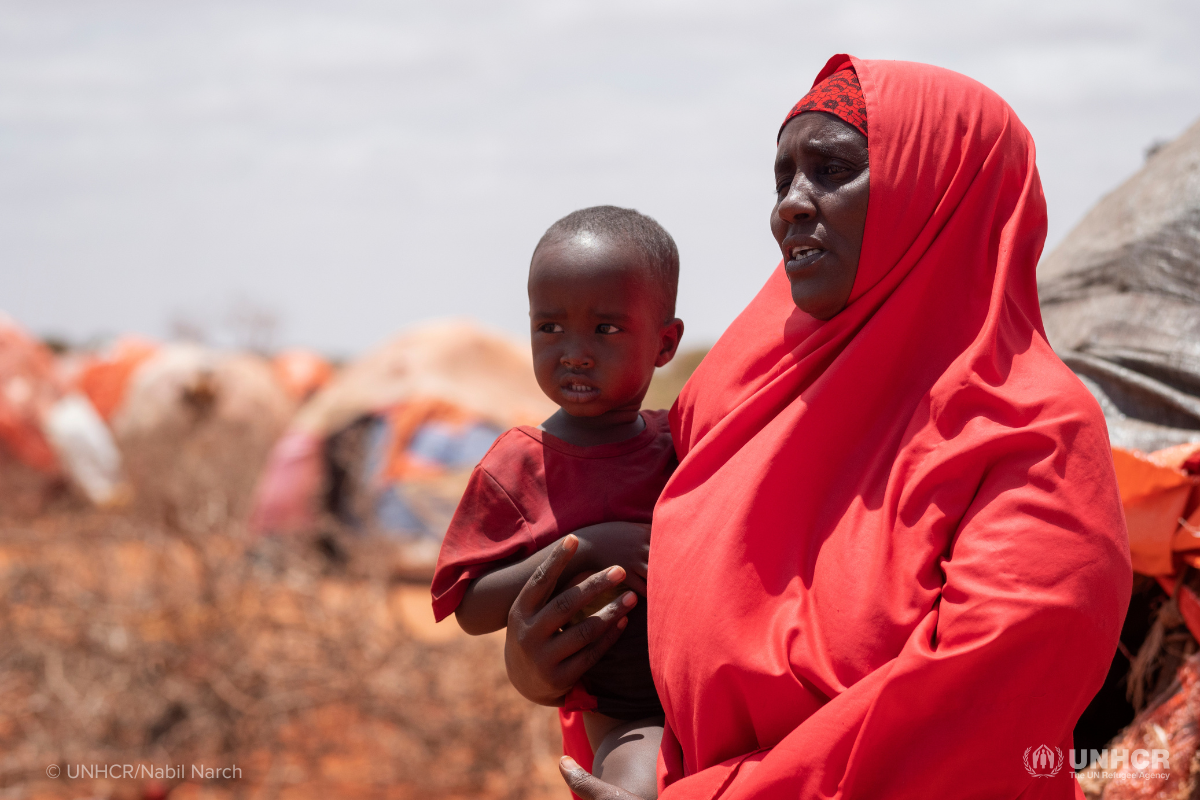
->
(454, 522), (650, 636)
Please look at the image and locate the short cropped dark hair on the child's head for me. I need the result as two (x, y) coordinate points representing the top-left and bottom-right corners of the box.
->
(533, 205), (679, 320)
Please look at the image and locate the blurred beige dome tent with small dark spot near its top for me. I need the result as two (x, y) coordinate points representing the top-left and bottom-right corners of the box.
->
(112, 344), (295, 529)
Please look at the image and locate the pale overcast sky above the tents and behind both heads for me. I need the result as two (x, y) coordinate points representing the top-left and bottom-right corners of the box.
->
(0, 0), (1200, 356)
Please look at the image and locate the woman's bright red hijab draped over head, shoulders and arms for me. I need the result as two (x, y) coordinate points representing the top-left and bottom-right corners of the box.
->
(647, 56), (1132, 800)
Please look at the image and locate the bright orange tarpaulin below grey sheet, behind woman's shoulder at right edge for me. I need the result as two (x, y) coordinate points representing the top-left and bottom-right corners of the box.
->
(1112, 443), (1200, 577)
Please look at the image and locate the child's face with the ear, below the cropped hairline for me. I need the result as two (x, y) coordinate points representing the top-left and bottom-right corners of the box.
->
(529, 234), (682, 417)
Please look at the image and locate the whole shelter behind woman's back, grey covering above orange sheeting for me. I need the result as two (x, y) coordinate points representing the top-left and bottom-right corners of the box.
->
(1038, 122), (1200, 800)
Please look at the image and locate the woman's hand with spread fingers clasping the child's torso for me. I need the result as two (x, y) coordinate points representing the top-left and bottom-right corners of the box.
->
(504, 534), (637, 705)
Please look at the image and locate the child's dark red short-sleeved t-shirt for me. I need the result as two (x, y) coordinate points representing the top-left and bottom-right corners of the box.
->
(432, 410), (677, 770)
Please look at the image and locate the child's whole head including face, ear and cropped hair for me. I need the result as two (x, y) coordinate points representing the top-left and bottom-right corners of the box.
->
(529, 205), (683, 416)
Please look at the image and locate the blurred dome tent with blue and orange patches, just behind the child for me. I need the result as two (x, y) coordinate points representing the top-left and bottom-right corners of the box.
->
(252, 320), (557, 544)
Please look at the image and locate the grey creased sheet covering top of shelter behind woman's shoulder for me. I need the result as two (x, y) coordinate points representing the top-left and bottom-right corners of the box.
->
(1038, 122), (1200, 452)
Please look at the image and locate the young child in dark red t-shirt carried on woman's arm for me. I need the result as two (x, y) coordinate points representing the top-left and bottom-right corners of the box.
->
(432, 206), (683, 799)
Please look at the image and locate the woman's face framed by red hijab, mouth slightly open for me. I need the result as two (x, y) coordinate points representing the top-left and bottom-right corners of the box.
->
(770, 112), (870, 319)
